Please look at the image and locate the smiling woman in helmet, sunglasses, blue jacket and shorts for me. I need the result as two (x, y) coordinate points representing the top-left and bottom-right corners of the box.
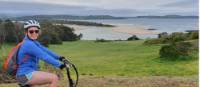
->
(16, 20), (66, 87)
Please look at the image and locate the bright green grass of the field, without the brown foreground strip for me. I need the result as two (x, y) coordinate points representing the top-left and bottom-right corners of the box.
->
(0, 40), (198, 77)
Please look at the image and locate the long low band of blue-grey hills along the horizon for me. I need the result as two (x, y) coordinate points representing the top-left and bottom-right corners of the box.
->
(0, 15), (199, 21)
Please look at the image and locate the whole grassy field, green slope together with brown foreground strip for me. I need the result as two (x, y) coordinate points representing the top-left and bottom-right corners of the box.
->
(0, 40), (198, 87)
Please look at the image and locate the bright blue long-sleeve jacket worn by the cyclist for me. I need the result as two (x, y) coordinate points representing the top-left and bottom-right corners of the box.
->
(16, 37), (61, 76)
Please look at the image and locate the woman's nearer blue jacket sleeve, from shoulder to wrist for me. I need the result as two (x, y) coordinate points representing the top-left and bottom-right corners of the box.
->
(25, 42), (61, 68)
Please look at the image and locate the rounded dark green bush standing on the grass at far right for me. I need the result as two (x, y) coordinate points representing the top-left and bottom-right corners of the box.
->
(159, 42), (191, 60)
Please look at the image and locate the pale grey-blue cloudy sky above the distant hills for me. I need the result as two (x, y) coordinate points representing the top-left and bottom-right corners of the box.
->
(0, 0), (199, 17)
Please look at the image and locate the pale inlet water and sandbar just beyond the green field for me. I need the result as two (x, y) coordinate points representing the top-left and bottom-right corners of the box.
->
(64, 24), (158, 40)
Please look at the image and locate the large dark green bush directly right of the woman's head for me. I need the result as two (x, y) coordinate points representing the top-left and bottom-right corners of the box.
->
(39, 21), (81, 46)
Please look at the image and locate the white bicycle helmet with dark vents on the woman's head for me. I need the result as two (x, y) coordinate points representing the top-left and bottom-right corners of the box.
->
(24, 20), (40, 30)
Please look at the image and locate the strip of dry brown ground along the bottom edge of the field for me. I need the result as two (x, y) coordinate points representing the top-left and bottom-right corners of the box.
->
(0, 76), (198, 87)
